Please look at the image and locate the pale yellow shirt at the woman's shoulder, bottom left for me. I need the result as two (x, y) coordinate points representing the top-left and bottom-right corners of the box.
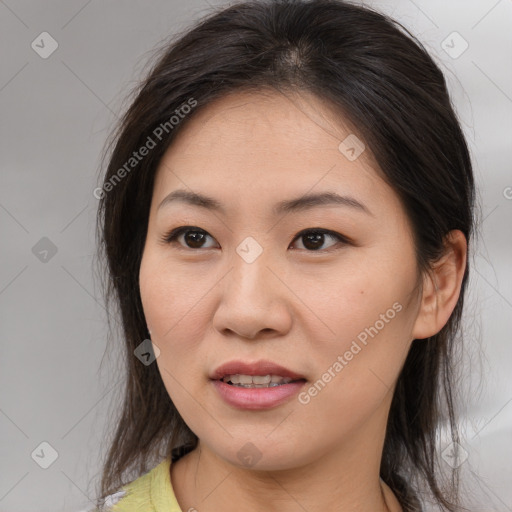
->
(98, 458), (182, 512)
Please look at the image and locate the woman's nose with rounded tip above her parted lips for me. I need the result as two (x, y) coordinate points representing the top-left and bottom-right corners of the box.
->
(212, 245), (292, 339)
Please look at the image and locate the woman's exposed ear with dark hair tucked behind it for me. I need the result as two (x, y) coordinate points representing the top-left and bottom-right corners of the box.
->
(412, 229), (467, 339)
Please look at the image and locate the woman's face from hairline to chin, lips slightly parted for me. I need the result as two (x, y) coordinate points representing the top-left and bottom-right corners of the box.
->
(140, 92), (420, 469)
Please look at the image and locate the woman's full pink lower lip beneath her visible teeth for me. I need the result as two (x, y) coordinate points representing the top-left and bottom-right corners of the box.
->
(212, 380), (306, 409)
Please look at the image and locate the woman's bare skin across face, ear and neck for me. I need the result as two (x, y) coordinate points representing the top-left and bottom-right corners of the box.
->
(139, 91), (466, 512)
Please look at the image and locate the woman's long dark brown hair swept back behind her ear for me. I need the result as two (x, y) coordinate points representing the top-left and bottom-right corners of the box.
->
(97, 0), (474, 512)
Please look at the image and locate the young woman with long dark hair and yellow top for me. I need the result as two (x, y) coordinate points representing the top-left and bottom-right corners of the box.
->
(90, 0), (474, 512)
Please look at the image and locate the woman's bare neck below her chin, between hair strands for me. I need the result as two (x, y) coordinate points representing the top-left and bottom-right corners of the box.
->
(171, 443), (402, 512)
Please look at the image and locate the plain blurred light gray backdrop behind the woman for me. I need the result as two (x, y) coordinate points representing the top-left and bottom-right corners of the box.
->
(0, 0), (512, 512)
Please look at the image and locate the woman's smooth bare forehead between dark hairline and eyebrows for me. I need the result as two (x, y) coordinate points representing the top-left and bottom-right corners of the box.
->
(153, 91), (397, 220)
